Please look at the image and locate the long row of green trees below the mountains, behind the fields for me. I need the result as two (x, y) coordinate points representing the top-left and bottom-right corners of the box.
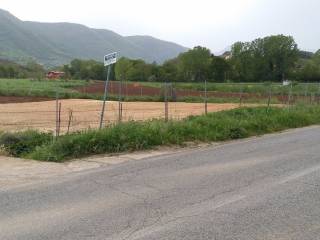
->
(0, 35), (320, 82)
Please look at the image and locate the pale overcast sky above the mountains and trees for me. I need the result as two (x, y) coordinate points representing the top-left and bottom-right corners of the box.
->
(0, 0), (320, 53)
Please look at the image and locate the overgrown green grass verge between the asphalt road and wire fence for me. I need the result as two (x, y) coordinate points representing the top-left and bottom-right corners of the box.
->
(0, 106), (320, 162)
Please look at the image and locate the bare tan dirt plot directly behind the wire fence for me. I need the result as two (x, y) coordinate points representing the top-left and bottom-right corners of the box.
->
(0, 99), (239, 133)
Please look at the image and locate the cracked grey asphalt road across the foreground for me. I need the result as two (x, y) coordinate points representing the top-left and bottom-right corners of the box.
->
(0, 127), (320, 240)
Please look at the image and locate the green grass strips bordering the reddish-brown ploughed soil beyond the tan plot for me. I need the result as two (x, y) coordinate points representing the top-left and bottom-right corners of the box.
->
(0, 79), (320, 103)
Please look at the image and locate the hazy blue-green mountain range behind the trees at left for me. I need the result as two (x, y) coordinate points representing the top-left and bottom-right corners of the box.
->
(0, 9), (188, 66)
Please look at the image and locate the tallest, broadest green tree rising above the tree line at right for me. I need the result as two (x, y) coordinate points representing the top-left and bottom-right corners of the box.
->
(231, 35), (299, 81)
